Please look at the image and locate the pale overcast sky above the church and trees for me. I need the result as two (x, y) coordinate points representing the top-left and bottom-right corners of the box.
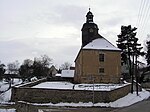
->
(0, 0), (150, 66)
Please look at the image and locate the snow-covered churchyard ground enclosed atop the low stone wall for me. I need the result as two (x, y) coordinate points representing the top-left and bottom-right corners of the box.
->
(32, 82), (127, 91)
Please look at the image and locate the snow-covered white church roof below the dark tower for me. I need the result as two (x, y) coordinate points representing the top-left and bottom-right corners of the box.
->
(82, 38), (121, 51)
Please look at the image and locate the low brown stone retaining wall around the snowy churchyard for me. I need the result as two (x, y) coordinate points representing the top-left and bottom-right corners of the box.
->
(11, 84), (131, 103)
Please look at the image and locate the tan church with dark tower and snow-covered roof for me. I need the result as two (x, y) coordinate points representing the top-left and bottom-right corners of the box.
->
(74, 9), (121, 83)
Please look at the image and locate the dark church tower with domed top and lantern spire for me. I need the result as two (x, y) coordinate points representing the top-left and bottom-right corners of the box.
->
(81, 8), (102, 47)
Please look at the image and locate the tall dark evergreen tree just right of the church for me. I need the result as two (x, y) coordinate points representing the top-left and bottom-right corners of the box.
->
(117, 25), (144, 93)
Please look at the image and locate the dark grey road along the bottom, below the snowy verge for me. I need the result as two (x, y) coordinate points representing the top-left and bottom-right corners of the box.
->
(39, 98), (150, 112)
